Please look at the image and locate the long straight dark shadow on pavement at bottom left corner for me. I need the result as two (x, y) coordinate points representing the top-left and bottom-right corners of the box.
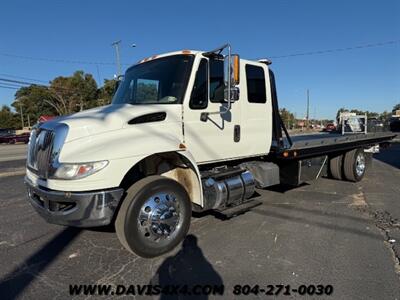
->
(0, 227), (81, 299)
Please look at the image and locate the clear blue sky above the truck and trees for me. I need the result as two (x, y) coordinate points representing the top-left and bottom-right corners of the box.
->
(0, 0), (400, 119)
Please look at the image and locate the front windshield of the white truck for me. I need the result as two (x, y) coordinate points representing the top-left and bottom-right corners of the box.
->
(112, 55), (194, 104)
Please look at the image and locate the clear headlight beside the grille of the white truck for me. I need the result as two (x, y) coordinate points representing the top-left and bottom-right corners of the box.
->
(52, 160), (108, 179)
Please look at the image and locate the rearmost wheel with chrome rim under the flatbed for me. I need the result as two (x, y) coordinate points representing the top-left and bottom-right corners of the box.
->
(343, 149), (367, 182)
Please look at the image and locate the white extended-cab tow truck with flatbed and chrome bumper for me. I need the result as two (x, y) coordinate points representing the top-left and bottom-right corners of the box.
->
(25, 44), (395, 257)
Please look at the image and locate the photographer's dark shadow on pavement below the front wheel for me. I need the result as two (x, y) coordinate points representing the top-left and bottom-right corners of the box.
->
(150, 234), (223, 299)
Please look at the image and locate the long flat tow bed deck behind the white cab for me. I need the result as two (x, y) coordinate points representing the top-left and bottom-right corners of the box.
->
(278, 132), (396, 159)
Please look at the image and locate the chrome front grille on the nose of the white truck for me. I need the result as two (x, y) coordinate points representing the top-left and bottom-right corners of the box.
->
(27, 129), (55, 178)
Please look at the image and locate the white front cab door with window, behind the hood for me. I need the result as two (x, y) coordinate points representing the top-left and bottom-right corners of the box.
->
(183, 55), (247, 164)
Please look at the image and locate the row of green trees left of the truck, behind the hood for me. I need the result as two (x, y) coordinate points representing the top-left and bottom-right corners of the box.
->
(0, 71), (116, 128)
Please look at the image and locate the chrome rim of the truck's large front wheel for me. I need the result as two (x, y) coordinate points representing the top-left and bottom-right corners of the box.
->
(138, 193), (182, 242)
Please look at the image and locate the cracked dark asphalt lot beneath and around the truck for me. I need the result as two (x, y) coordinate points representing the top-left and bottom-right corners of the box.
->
(0, 144), (400, 299)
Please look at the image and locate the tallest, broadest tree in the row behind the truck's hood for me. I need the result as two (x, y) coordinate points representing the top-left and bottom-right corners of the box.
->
(45, 71), (98, 115)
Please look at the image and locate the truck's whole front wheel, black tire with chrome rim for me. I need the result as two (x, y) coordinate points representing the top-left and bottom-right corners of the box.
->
(115, 176), (192, 258)
